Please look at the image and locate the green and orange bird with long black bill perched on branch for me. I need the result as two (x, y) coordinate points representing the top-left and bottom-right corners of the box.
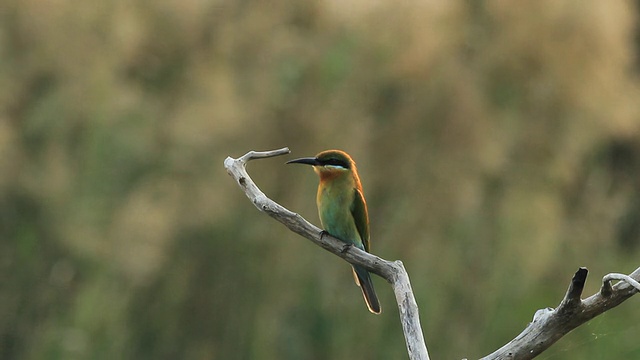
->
(287, 150), (382, 314)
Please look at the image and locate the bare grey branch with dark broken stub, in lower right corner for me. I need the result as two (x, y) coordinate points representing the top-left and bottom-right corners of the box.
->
(482, 268), (640, 360)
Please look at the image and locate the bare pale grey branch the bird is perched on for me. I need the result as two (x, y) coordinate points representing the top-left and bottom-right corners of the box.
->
(224, 148), (429, 360)
